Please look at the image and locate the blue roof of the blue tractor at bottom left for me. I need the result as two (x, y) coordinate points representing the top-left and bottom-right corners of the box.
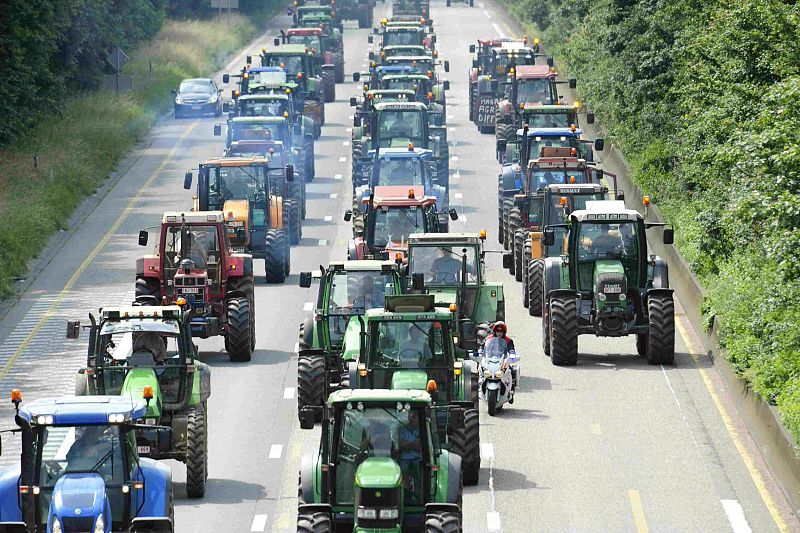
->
(19, 396), (147, 426)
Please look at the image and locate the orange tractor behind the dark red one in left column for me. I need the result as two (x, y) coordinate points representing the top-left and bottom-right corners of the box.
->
(183, 154), (303, 247)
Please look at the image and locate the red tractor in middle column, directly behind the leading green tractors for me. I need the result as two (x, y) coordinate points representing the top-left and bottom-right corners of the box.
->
(344, 186), (458, 260)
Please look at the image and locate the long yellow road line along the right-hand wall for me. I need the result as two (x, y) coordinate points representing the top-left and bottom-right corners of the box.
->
(675, 316), (789, 531)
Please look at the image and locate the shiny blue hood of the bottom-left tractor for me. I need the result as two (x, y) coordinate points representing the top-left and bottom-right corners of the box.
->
(49, 473), (106, 531)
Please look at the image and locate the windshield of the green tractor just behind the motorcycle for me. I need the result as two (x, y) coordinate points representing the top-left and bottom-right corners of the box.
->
(408, 245), (478, 285)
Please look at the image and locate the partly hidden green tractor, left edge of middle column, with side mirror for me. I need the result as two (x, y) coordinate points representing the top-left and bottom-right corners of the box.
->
(297, 260), (402, 415)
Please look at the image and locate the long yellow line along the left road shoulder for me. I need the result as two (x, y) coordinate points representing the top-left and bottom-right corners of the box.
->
(0, 121), (197, 379)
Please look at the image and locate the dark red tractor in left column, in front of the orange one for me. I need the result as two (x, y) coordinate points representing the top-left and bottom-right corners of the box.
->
(135, 211), (258, 361)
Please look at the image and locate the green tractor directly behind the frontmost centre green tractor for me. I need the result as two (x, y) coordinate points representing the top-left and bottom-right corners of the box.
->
(342, 294), (481, 485)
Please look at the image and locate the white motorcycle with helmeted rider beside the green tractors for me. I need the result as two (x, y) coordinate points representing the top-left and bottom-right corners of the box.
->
(478, 337), (519, 416)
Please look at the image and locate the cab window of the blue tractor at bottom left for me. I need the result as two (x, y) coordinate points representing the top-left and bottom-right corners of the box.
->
(34, 425), (130, 531)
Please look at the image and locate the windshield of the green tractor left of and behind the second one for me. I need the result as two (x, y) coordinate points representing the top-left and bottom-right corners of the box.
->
(328, 270), (398, 346)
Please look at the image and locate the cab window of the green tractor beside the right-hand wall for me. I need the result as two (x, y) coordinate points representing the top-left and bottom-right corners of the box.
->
(577, 221), (639, 290)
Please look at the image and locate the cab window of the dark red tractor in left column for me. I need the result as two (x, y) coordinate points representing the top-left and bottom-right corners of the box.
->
(163, 225), (220, 291)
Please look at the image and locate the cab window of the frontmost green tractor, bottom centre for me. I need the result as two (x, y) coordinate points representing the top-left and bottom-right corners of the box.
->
(333, 402), (429, 505)
